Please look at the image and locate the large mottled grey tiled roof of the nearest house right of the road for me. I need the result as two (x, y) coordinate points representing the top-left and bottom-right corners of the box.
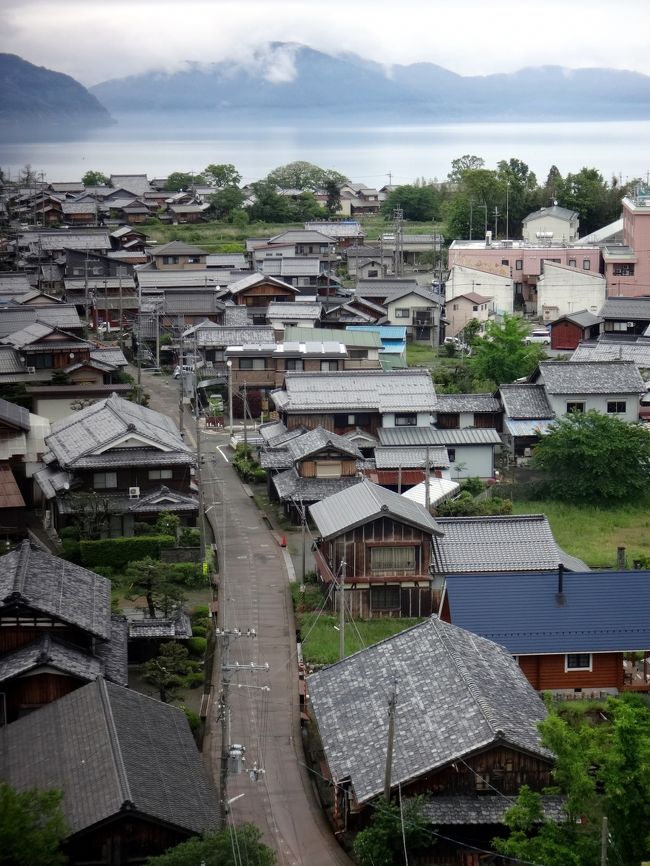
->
(307, 617), (550, 803)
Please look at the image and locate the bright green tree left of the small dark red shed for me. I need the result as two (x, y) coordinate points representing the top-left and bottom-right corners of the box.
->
(469, 314), (544, 385)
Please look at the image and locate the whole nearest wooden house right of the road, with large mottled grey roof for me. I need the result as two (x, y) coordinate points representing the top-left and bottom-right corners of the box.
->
(307, 617), (561, 866)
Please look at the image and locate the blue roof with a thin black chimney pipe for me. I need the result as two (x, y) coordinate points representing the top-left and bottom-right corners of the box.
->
(446, 571), (650, 655)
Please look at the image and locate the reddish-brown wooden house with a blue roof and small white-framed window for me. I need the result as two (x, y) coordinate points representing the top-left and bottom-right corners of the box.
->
(441, 565), (650, 697)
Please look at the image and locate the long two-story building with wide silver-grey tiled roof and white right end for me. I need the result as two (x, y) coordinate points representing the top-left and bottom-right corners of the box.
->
(271, 368), (436, 435)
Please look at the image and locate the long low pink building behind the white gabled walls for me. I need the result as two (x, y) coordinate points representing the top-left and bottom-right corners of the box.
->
(449, 238), (596, 313)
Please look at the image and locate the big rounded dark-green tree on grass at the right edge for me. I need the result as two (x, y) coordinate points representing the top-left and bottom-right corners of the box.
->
(533, 411), (650, 502)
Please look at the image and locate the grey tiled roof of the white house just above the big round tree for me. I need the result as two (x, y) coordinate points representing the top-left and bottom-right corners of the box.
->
(539, 361), (645, 394)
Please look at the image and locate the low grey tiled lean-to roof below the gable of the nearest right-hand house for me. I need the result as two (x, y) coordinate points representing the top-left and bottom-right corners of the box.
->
(422, 793), (566, 827)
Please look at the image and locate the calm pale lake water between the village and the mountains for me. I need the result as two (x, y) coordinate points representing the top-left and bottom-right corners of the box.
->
(0, 121), (650, 187)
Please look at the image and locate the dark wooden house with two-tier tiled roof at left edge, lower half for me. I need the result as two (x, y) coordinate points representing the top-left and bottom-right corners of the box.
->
(0, 541), (127, 724)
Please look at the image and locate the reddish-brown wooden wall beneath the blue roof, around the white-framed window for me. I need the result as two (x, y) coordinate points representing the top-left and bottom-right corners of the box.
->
(519, 653), (624, 691)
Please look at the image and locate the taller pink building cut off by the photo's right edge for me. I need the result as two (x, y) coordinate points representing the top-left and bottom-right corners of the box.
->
(602, 189), (650, 298)
